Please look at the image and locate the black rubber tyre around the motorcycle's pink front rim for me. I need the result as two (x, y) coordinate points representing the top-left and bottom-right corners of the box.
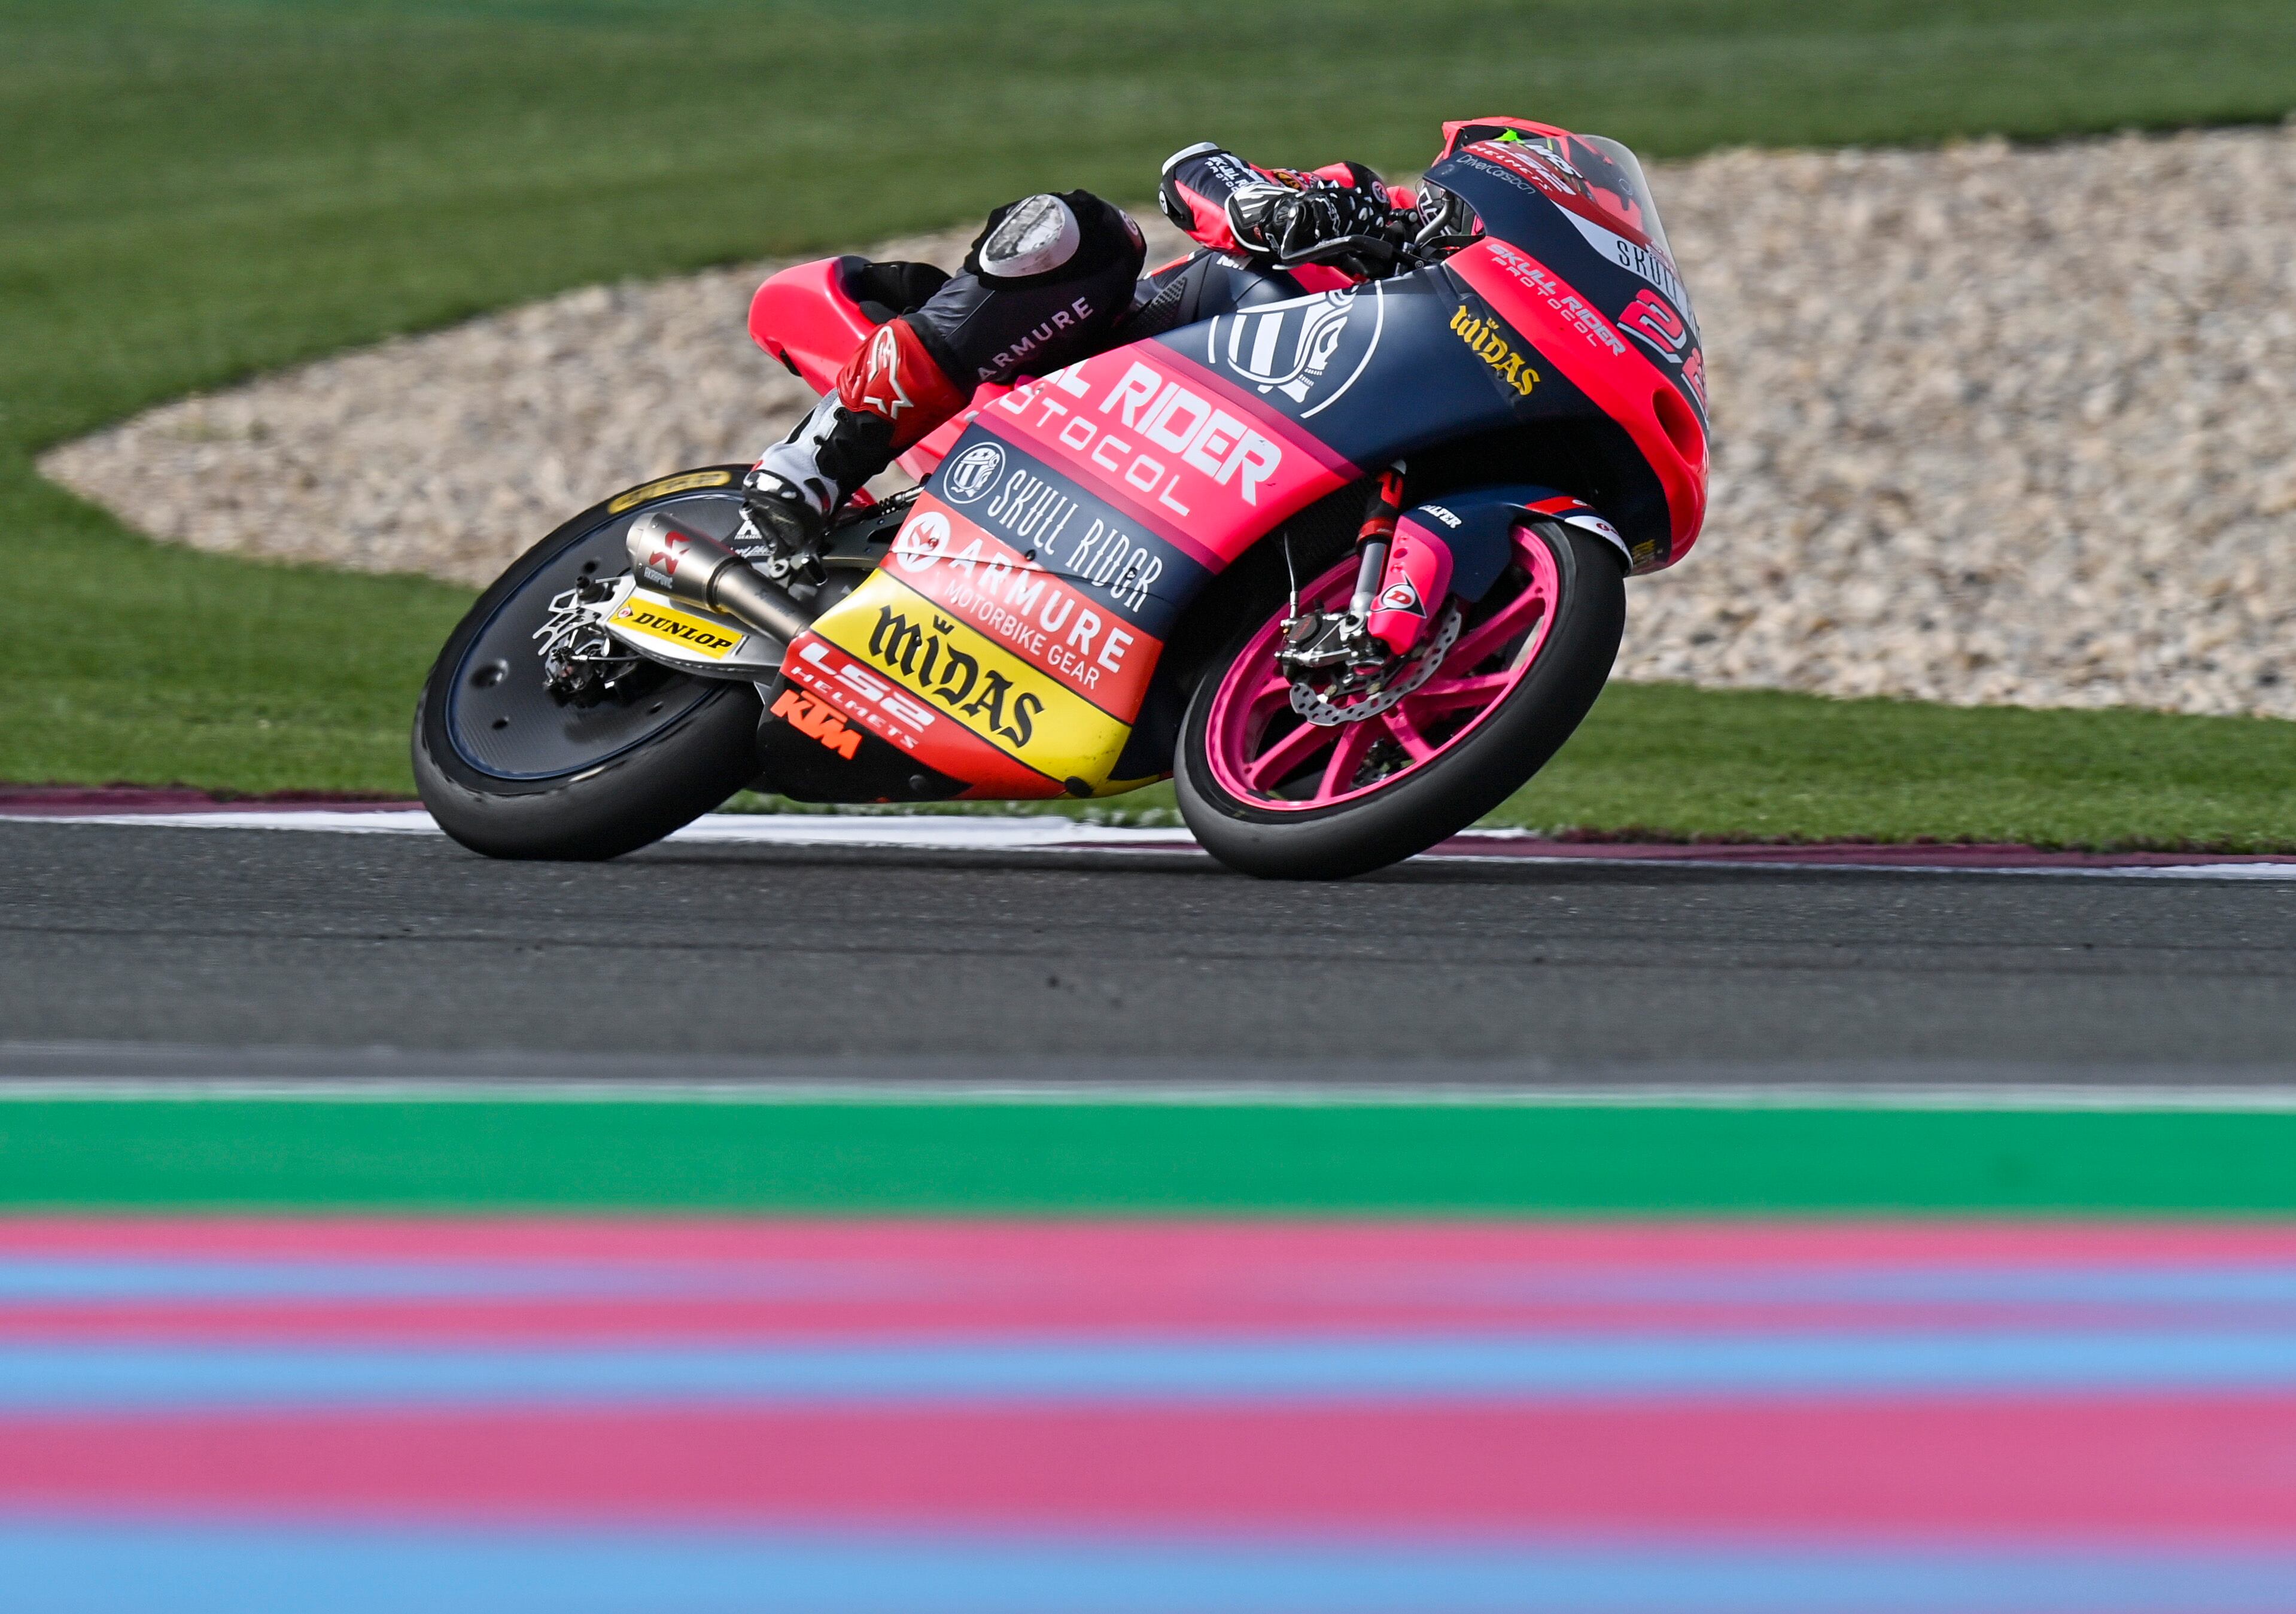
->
(1173, 523), (1626, 879)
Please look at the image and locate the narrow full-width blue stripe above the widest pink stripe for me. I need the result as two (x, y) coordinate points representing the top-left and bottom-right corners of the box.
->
(0, 1332), (2296, 1412)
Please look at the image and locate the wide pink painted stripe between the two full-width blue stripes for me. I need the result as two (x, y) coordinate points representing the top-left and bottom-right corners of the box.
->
(13, 1398), (2296, 1540)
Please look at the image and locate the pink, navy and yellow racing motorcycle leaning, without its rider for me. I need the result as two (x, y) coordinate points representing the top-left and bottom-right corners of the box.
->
(413, 129), (1706, 877)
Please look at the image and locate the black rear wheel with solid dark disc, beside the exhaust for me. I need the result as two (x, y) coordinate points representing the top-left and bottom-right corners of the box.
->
(413, 466), (760, 861)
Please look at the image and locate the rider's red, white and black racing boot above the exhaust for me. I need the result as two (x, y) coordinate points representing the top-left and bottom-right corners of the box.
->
(741, 319), (966, 578)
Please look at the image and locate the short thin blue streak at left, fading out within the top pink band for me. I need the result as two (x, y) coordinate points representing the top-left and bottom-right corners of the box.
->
(0, 1256), (904, 1307)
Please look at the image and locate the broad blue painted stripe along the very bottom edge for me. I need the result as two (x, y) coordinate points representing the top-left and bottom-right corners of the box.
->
(0, 1520), (2296, 1614)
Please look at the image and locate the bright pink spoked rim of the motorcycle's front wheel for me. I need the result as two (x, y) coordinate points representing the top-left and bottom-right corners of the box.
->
(1205, 528), (1561, 813)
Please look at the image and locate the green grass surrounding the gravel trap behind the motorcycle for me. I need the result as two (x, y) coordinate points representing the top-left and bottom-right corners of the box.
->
(0, 0), (2296, 821)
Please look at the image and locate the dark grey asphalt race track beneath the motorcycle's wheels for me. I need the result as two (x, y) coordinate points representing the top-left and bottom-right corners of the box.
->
(0, 822), (2296, 1083)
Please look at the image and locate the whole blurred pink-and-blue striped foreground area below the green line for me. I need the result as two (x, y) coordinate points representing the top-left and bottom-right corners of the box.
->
(0, 1217), (2296, 1614)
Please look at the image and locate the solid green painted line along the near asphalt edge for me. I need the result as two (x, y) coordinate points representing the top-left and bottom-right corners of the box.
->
(0, 1100), (2296, 1214)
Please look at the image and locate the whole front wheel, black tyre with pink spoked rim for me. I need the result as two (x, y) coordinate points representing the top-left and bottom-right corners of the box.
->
(1173, 521), (1626, 879)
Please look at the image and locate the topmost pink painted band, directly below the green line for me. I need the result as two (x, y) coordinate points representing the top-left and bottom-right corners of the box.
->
(17, 1217), (2296, 1343)
